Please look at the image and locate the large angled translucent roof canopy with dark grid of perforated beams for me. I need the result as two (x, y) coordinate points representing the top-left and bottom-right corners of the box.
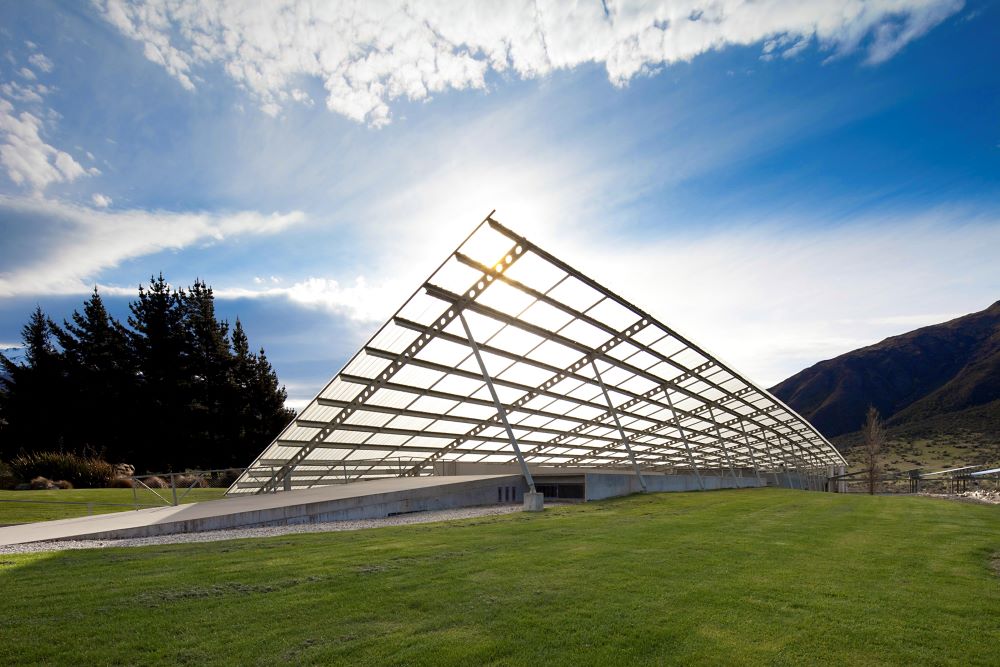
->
(230, 217), (844, 493)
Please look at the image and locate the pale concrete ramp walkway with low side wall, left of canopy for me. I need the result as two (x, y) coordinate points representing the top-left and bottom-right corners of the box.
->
(0, 475), (521, 545)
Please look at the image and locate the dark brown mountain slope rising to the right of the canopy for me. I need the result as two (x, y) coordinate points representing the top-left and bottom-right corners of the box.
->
(771, 301), (1000, 437)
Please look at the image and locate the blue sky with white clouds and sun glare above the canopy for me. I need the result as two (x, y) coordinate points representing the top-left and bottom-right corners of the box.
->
(0, 0), (1000, 406)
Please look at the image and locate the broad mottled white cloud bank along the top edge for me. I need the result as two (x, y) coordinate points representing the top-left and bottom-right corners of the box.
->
(94, 0), (963, 126)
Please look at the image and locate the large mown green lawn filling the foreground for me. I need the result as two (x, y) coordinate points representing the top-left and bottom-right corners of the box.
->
(0, 489), (1000, 665)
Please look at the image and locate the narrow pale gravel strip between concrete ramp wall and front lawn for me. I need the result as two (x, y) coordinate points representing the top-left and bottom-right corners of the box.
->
(0, 505), (521, 555)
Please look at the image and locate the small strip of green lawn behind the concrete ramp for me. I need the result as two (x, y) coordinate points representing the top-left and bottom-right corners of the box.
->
(0, 489), (226, 526)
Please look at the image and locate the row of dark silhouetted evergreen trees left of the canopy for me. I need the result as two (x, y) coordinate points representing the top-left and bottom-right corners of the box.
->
(0, 274), (294, 472)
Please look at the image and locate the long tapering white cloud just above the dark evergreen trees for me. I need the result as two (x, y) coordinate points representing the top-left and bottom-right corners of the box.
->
(0, 196), (305, 297)
